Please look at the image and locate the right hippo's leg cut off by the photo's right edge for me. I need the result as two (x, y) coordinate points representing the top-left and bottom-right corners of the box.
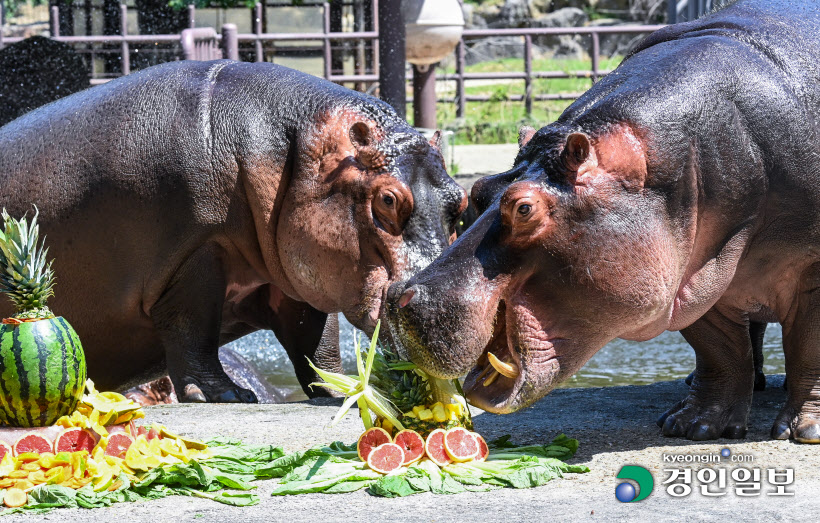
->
(771, 279), (820, 443)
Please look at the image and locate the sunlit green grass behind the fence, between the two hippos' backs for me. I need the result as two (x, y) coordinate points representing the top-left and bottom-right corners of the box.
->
(426, 57), (621, 144)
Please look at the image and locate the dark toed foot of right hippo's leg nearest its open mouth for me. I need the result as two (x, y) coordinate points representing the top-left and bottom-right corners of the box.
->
(658, 394), (749, 441)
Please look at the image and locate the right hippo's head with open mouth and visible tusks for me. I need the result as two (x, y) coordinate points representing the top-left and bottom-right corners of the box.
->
(388, 125), (691, 413)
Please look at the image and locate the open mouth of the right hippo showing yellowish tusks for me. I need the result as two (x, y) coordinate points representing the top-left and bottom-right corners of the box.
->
(464, 300), (558, 414)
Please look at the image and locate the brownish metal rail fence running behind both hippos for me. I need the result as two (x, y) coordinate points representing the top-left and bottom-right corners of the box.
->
(0, 0), (663, 117)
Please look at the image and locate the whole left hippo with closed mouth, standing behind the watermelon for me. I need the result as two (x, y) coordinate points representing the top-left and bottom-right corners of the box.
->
(0, 60), (467, 402)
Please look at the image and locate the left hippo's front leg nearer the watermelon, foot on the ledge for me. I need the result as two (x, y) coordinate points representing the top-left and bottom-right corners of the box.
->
(151, 245), (256, 403)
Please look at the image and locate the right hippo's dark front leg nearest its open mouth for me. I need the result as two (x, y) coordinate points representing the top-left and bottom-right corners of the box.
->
(658, 308), (754, 440)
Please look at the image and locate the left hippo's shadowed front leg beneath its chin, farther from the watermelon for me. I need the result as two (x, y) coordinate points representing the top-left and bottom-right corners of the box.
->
(271, 295), (342, 398)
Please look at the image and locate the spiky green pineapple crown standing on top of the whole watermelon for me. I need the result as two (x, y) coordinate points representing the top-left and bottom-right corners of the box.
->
(0, 206), (54, 315)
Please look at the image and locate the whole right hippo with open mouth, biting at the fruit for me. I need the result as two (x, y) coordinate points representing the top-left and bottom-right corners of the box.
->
(387, 0), (820, 443)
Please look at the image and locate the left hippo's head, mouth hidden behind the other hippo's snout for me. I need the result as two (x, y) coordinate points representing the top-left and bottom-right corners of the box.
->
(276, 108), (467, 333)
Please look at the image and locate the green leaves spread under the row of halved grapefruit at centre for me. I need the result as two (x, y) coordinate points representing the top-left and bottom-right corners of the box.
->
(271, 434), (589, 497)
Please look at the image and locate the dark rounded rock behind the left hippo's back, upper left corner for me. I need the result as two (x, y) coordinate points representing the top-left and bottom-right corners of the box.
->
(0, 36), (90, 125)
